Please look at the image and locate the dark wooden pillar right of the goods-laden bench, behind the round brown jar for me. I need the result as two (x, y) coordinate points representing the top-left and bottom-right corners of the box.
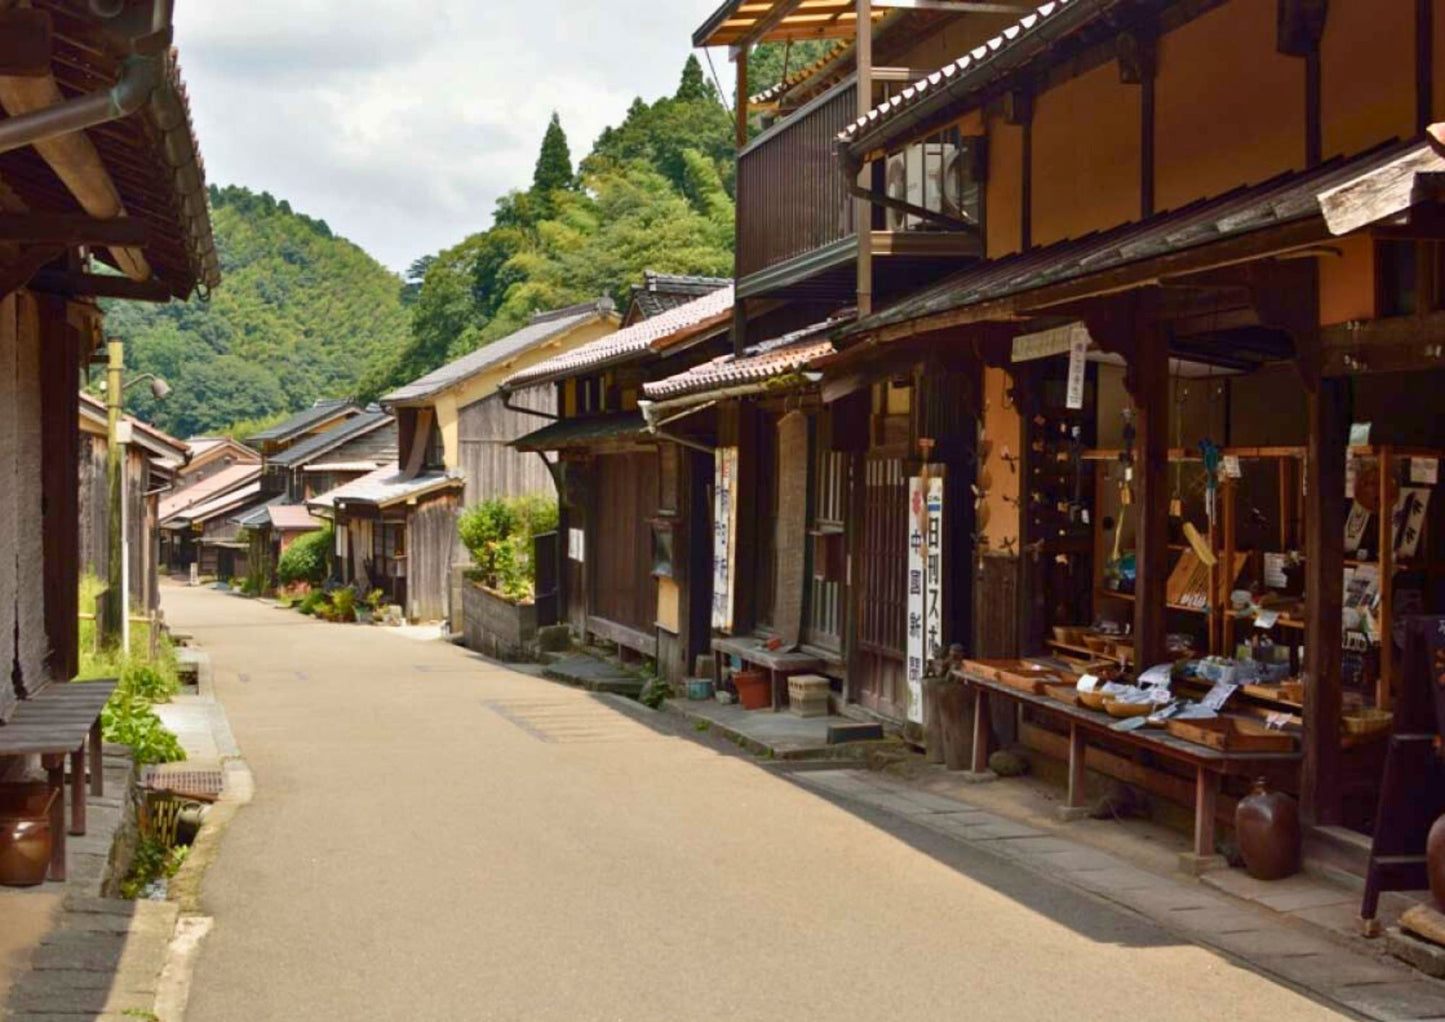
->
(1301, 379), (1348, 824)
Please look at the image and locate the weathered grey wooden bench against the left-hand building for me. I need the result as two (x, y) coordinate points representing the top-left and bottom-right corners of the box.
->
(0, 678), (117, 880)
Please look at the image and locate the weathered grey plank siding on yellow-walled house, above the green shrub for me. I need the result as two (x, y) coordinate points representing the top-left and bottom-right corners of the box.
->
(458, 386), (556, 504)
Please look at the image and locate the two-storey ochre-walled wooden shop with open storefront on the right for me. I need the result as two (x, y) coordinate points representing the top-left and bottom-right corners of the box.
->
(698, 0), (1445, 870)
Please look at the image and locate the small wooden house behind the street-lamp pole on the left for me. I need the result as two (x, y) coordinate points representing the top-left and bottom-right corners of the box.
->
(77, 393), (191, 610)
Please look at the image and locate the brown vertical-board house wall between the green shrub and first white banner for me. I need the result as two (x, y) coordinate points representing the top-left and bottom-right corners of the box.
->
(587, 451), (657, 635)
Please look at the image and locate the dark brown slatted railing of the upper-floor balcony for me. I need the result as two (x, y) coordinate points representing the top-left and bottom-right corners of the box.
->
(737, 78), (857, 279)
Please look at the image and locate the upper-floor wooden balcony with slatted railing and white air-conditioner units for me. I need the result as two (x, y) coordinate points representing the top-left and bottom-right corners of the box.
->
(737, 68), (981, 301)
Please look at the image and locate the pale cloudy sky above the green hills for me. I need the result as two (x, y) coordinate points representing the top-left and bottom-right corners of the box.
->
(175, 0), (731, 272)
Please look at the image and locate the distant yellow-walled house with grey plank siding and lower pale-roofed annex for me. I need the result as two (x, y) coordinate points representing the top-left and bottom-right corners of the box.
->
(319, 298), (618, 620)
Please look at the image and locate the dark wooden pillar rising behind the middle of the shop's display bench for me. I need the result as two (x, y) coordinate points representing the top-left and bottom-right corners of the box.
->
(1129, 319), (1169, 669)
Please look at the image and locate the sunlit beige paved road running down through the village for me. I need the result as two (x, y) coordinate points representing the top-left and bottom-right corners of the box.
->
(165, 588), (1338, 1022)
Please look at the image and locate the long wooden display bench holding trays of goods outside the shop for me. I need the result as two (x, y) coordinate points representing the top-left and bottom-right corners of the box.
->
(954, 666), (1302, 873)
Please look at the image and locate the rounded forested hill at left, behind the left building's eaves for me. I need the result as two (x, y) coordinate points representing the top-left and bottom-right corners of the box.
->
(105, 185), (410, 437)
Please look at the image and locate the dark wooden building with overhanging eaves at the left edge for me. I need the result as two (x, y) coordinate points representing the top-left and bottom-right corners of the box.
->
(0, 0), (220, 728)
